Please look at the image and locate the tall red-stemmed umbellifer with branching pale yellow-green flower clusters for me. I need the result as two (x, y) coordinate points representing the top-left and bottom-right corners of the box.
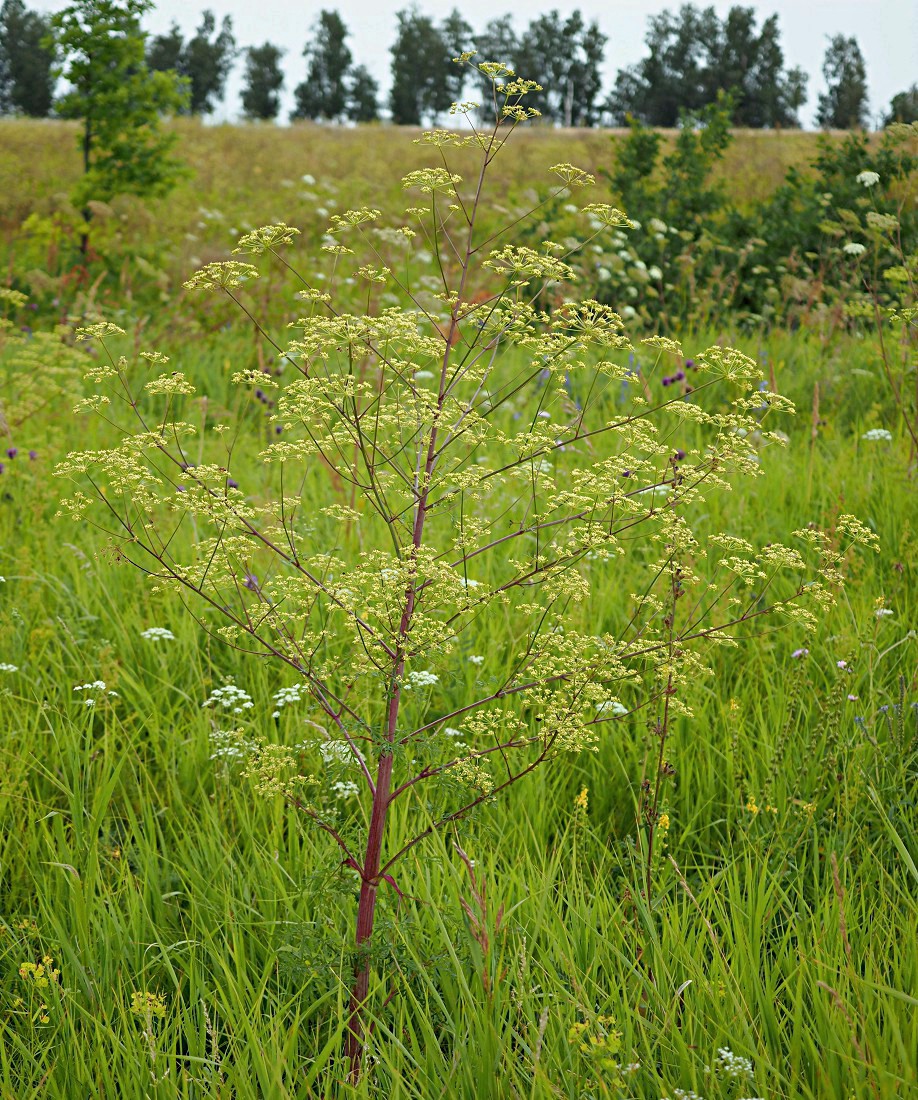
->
(59, 57), (866, 1077)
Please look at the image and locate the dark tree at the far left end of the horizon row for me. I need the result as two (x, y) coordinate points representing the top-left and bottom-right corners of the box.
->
(0, 0), (55, 119)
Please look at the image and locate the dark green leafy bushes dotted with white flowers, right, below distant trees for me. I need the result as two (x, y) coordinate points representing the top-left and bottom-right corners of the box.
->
(584, 111), (918, 327)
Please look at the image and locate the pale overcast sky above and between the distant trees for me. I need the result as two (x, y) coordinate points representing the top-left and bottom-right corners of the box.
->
(44, 0), (918, 125)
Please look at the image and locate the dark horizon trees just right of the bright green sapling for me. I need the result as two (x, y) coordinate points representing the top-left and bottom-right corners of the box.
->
(146, 11), (236, 114)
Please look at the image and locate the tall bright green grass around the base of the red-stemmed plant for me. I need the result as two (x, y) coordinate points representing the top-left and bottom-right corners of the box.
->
(0, 316), (918, 1100)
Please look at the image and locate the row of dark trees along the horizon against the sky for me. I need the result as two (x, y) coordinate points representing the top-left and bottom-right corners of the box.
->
(0, 0), (918, 129)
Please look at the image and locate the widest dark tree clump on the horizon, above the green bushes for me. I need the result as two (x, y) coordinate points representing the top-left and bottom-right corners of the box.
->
(607, 3), (807, 127)
